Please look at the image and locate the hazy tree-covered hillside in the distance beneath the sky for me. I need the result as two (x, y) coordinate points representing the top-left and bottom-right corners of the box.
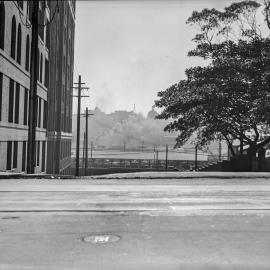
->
(72, 107), (176, 150)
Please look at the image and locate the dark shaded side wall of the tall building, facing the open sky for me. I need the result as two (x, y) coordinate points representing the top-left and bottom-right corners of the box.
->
(47, 1), (75, 174)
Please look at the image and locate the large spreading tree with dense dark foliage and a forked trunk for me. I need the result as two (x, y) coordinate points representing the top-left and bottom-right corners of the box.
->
(156, 1), (270, 170)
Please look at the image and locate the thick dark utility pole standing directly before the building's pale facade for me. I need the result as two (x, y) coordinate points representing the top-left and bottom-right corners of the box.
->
(27, 0), (39, 174)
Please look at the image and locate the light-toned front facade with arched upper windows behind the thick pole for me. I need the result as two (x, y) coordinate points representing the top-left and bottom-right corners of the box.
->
(0, 1), (50, 172)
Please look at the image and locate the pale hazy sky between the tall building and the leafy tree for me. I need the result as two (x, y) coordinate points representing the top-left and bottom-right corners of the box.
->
(74, 0), (238, 114)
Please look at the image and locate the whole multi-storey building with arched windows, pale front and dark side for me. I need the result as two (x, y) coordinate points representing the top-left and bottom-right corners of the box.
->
(0, 1), (75, 173)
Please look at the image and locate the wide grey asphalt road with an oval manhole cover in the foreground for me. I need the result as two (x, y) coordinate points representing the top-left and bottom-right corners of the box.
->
(0, 178), (270, 270)
